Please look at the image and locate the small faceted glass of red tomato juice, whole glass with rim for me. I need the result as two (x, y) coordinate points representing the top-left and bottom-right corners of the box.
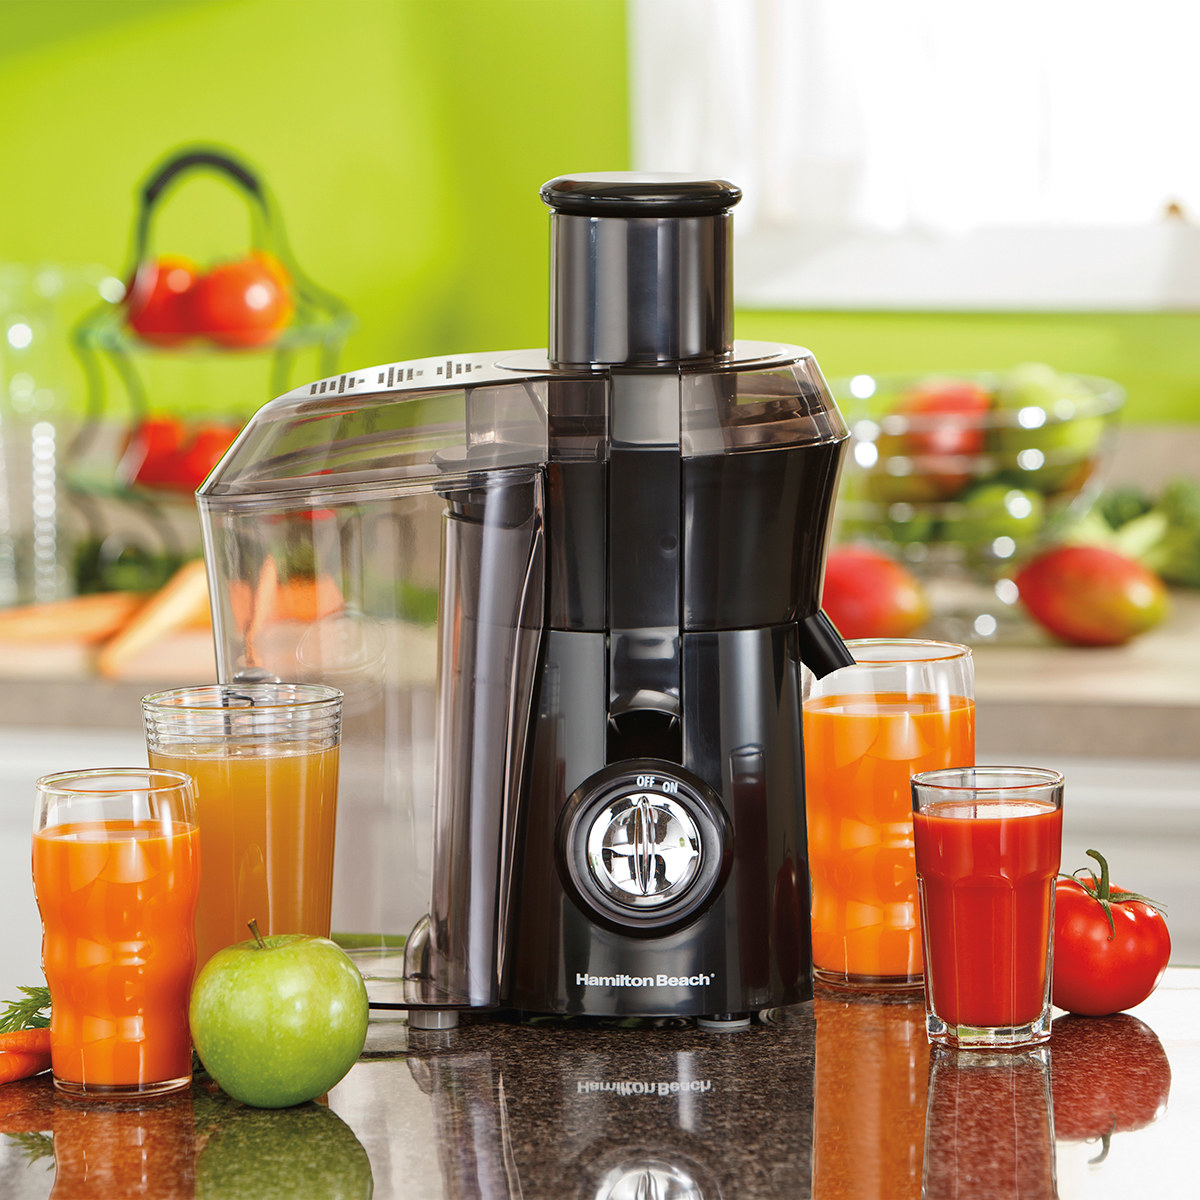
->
(912, 767), (1063, 1049)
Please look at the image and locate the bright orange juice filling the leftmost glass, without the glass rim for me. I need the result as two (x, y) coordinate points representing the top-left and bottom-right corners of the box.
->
(34, 821), (199, 1087)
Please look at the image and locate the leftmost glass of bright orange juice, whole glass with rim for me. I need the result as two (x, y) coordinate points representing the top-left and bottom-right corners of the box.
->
(34, 767), (199, 1099)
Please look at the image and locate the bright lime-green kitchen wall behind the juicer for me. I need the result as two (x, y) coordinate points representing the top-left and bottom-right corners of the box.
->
(0, 0), (1200, 421)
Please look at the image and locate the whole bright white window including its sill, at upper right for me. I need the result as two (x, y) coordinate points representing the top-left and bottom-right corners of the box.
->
(630, 0), (1200, 310)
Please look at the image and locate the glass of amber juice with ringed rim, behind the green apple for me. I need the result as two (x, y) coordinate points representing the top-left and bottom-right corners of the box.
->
(142, 683), (342, 966)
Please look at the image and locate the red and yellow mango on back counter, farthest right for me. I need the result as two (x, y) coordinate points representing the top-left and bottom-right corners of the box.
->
(1015, 546), (1166, 646)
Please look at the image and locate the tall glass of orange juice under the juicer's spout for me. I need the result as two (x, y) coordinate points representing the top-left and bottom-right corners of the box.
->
(803, 638), (974, 989)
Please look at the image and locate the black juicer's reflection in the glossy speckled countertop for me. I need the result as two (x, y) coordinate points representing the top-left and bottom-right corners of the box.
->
(407, 1010), (812, 1200)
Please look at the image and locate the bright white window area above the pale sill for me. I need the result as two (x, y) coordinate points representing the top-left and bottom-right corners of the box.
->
(630, 0), (1200, 235)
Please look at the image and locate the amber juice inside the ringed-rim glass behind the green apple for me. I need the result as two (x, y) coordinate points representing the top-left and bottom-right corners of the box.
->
(150, 746), (338, 966)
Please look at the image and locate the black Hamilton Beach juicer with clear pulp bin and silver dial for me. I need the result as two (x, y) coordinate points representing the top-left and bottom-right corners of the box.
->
(198, 175), (850, 1027)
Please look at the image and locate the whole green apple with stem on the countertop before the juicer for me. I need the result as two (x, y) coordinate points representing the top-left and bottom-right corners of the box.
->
(188, 923), (370, 1109)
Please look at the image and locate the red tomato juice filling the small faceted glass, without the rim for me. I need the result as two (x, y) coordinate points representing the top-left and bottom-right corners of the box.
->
(913, 800), (1062, 1027)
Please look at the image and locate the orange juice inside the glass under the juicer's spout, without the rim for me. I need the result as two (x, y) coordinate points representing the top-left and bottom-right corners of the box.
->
(804, 692), (974, 979)
